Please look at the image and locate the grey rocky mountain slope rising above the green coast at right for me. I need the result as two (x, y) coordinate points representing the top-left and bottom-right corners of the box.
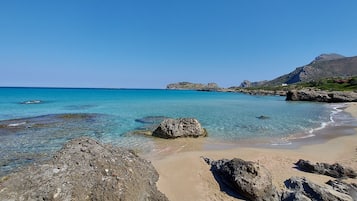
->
(241, 54), (357, 87)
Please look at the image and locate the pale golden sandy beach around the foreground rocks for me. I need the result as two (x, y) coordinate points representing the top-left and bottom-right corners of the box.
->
(149, 103), (357, 201)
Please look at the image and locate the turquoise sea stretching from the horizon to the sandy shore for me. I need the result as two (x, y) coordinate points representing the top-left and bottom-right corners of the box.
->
(0, 87), (357, 176)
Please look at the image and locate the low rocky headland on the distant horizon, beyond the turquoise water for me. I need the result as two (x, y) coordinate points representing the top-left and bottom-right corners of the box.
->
(166, 82), (220, 91)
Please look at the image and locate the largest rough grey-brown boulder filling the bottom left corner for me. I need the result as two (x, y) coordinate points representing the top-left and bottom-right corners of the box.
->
(0, 137), (168, 201)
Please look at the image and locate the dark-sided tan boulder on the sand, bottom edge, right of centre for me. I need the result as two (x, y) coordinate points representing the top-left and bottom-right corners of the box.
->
(204, 158), (280, 201)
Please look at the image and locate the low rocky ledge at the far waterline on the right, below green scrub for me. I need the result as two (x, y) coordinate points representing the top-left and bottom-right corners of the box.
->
(286, 88), (357, 103)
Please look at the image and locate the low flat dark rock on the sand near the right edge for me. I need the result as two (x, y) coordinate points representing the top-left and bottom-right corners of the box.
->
(295, 159), (357, 178)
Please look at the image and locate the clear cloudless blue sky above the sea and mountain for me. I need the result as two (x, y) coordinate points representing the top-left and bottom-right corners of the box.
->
(0, 0), (357, 88)
